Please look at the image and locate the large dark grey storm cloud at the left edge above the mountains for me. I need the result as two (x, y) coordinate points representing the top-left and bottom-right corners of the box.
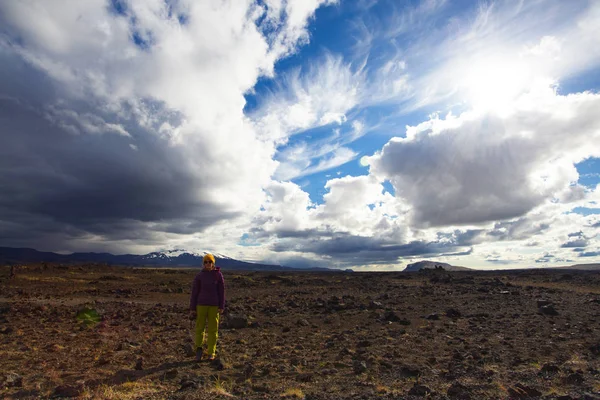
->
(0, 52), (239, 250)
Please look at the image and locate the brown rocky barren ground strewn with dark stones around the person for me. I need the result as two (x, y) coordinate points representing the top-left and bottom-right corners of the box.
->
(0, 264), (600, 400)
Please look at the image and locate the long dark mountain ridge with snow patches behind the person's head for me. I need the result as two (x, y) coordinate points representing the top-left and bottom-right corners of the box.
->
(0, 247), (333, 271)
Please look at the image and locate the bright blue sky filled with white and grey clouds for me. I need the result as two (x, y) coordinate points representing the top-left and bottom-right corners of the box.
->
(0, 0), (600, 271)
